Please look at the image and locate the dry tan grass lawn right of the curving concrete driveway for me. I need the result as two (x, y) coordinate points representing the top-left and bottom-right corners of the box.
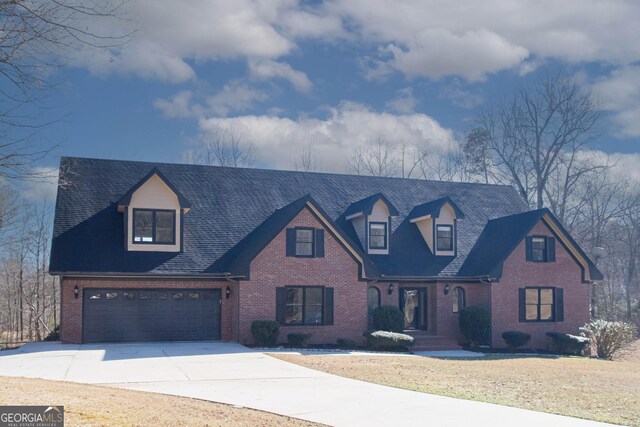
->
(272, 341), (640, 427)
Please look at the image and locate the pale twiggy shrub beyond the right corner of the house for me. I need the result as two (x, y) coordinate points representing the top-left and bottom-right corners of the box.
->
(580, 320), (636, 360)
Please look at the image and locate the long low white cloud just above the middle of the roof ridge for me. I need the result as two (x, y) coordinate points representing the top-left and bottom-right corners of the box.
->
(200, 102), (453, 172)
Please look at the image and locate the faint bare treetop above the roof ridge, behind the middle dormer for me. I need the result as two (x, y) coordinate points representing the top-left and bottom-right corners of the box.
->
(347, 137), (402, 177)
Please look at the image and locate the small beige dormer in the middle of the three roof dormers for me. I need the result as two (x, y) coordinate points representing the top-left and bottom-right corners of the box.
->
(344, 193), (398, 255)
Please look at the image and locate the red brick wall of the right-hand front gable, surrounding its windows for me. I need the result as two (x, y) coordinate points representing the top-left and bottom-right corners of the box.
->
(491, 222), (589, 349)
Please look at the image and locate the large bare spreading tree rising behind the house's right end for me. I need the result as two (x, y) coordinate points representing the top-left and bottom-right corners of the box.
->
(466, 75), (600, 208)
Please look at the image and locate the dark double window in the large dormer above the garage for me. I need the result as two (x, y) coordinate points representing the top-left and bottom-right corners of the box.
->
(133, 209), (176, 245)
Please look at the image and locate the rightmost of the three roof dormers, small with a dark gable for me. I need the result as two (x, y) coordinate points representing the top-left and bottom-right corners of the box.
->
(408, 197), (464, 256)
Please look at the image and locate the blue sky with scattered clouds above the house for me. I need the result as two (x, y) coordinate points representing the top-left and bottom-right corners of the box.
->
(31, 0), (640, 197)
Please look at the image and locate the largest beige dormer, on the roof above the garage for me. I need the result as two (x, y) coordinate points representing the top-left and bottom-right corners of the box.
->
(118, 168), (191, 252)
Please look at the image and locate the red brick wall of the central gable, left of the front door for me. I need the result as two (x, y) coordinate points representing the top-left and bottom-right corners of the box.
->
(239, 209), (364, 344)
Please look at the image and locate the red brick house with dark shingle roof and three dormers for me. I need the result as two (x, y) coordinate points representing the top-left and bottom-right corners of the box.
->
(50, 158), (602, 348)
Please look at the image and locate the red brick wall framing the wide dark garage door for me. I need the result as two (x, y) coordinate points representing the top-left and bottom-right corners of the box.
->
(60, 278), (238, 343)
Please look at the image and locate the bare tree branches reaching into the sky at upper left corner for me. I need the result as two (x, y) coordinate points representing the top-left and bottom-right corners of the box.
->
(0, 0), (128, 178)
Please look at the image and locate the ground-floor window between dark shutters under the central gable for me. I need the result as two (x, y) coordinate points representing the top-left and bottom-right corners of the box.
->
(285, 287), (324, 325)
